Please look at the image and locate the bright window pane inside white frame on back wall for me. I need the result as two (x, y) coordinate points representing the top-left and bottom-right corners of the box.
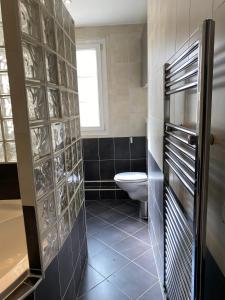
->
(77, 49), (101, 127)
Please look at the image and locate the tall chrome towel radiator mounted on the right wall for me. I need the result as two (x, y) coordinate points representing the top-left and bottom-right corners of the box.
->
(163, 20), (214, 300)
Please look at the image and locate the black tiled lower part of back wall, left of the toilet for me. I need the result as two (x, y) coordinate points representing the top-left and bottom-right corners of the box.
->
(83, 137), (146, 200)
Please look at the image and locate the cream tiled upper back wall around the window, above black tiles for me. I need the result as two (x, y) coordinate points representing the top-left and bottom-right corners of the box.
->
(76, 25), (147, 137)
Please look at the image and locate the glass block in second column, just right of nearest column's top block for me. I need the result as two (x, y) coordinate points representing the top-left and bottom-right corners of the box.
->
(42, 10), (56, 50)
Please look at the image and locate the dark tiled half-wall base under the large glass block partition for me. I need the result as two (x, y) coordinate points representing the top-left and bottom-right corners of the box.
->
(26, 206), (87, 300)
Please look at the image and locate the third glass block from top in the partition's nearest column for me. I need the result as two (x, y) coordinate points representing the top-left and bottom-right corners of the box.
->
(26, 86), (47, 121)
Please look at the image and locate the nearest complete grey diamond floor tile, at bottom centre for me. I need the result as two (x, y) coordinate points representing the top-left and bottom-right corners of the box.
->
(109, 263), (157, 299)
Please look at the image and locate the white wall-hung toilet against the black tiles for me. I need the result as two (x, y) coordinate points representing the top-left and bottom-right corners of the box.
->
(114, 172), (148, 219)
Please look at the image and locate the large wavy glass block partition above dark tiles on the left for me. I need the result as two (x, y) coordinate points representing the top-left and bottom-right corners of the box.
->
(2, 0), (84, 269)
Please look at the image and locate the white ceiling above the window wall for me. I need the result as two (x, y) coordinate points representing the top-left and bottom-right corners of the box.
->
(67, 0), (147, 26)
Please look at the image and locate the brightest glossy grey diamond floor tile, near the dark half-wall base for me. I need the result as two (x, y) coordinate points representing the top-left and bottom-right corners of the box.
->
(89, 249), (129, 278)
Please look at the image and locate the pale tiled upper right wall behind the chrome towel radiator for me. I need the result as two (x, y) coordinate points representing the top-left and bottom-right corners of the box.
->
(148, 0), (225, 275)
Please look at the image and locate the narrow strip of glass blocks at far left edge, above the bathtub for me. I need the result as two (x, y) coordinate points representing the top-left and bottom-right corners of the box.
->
(0, 5), (16, 164)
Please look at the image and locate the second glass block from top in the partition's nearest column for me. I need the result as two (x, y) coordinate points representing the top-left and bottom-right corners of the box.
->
(23, 43), (43, 80)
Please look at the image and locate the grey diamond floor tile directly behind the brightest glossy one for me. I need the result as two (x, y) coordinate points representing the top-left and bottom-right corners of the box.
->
(93, 225), (128, 245)
